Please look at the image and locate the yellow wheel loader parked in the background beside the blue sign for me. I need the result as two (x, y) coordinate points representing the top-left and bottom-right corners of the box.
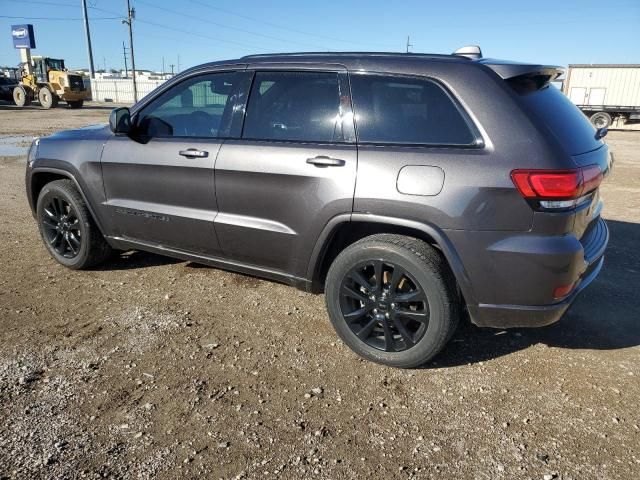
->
(13, 56), (91, 108)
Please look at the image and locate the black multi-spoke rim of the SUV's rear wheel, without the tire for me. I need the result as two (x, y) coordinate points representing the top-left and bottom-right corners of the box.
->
(340, 260), (429, 352)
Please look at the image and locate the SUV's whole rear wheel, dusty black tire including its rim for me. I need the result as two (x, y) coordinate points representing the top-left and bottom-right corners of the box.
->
(325, 234), (460, 368)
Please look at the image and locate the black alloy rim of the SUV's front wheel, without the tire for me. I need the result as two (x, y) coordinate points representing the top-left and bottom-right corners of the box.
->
(41, 196), (82, 259)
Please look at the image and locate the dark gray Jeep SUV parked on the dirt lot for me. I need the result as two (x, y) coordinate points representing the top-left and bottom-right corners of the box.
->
(26, 49), (611, 367)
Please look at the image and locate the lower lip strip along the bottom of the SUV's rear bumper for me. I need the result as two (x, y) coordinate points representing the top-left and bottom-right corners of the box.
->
(468, 256), (604, 328)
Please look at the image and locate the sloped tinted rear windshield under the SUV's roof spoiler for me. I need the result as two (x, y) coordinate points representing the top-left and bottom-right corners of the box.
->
(516, 85), (602, 155)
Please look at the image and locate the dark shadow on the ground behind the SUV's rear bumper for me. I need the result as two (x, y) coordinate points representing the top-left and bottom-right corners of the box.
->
(425, 220), (640, 368)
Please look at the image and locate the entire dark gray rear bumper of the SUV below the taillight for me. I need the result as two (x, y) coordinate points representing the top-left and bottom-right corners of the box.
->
(454, 218), (609, 328)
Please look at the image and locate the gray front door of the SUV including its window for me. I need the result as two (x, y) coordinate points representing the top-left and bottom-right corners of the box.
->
(102, 72), (245, 255)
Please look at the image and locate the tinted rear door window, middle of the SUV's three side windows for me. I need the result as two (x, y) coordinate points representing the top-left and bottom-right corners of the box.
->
(242, 72), (344, 142)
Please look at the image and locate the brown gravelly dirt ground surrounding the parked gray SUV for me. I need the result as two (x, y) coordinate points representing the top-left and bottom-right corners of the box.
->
(0, 106), (640, 480)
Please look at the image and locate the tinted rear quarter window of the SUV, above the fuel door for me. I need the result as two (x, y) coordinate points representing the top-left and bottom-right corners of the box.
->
(351, 75), (476, 145)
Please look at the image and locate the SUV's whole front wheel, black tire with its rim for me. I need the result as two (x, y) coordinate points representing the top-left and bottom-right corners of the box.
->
(36, 179), (111, 270)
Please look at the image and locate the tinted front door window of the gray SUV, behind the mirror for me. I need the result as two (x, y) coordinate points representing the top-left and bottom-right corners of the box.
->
(138, 72), (242, 138)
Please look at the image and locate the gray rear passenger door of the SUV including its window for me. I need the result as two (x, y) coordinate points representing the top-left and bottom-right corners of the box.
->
(215, 66), (357, 277)
